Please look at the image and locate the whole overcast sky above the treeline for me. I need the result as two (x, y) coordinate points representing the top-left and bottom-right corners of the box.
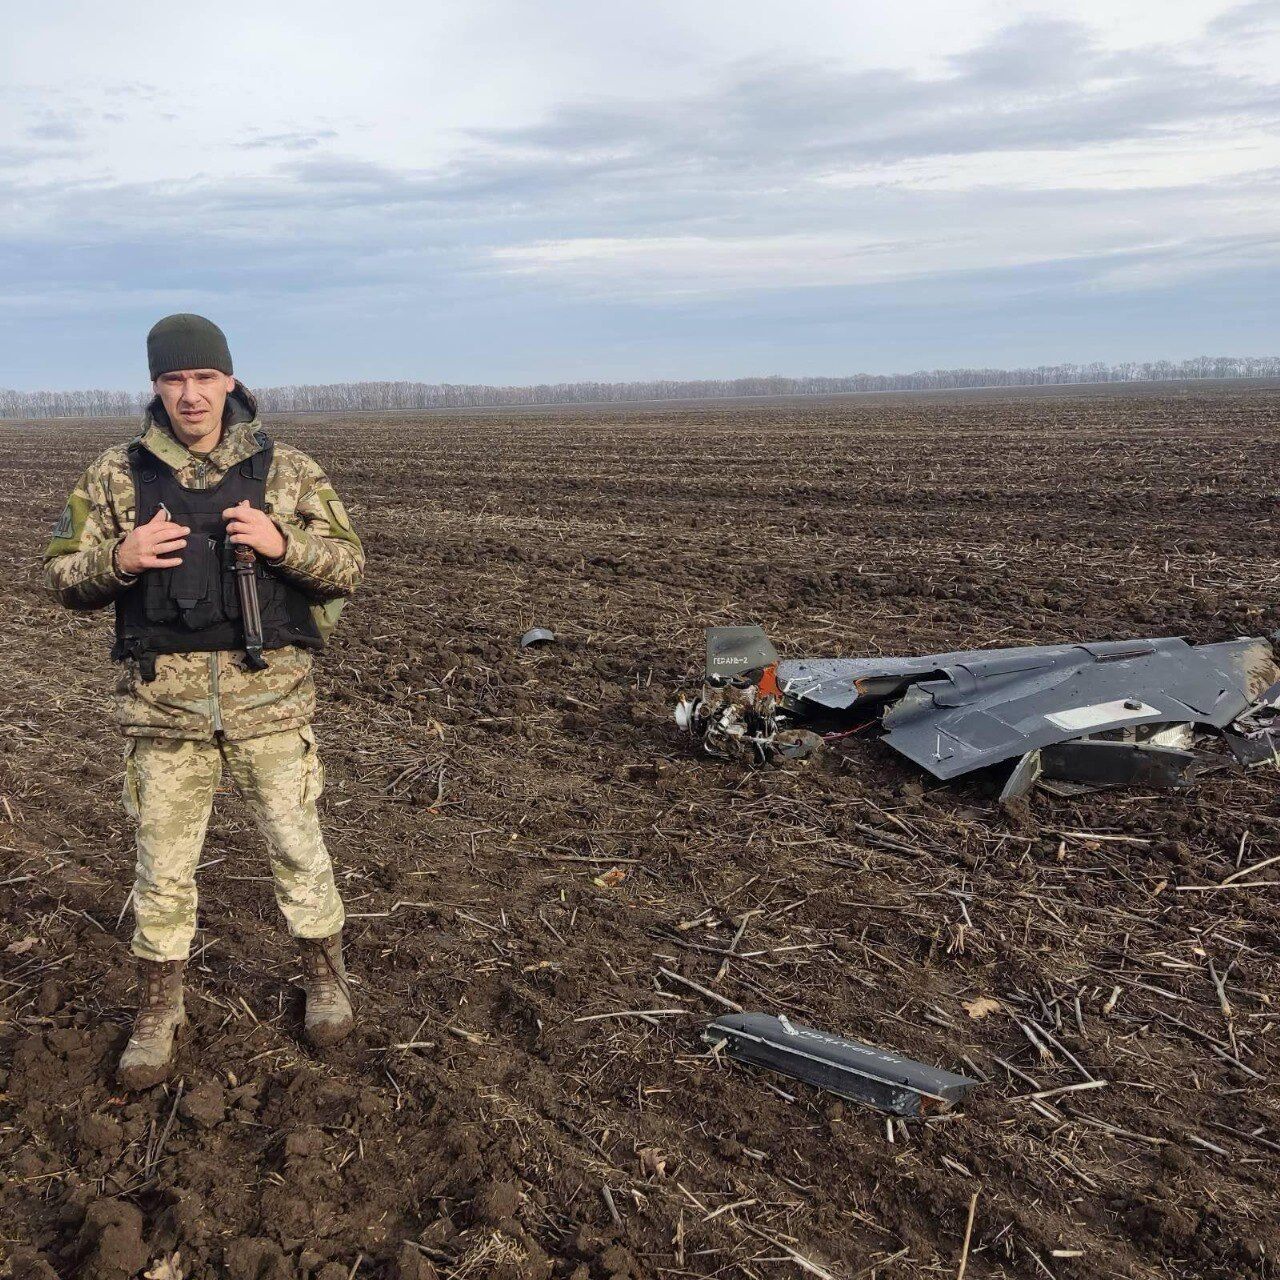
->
(0, 0), (1280, 389)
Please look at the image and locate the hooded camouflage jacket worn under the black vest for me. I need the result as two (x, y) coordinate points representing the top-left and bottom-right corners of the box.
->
(45, 387), (365, 740)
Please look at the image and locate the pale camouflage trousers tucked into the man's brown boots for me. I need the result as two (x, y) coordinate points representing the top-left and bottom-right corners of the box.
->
(124, 727), (343, 960)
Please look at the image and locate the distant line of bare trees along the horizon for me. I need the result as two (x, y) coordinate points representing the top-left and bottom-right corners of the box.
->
(0, 356), (1280, 417)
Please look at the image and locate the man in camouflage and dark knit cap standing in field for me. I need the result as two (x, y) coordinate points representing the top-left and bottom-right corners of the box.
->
(45, 315), (365, 1089)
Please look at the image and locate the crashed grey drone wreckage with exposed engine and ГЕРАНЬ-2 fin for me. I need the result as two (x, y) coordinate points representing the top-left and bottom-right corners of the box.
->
(676, 626), (1280, 800)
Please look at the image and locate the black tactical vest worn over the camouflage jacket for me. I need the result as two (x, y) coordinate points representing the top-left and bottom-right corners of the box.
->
(111, 431), (323, 678)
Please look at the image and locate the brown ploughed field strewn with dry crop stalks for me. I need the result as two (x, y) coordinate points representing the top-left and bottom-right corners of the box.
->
(0, 385), (1280, 1280)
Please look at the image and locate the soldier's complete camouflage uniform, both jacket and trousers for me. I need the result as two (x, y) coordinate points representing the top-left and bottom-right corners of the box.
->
(45, 388), (365, 960)
